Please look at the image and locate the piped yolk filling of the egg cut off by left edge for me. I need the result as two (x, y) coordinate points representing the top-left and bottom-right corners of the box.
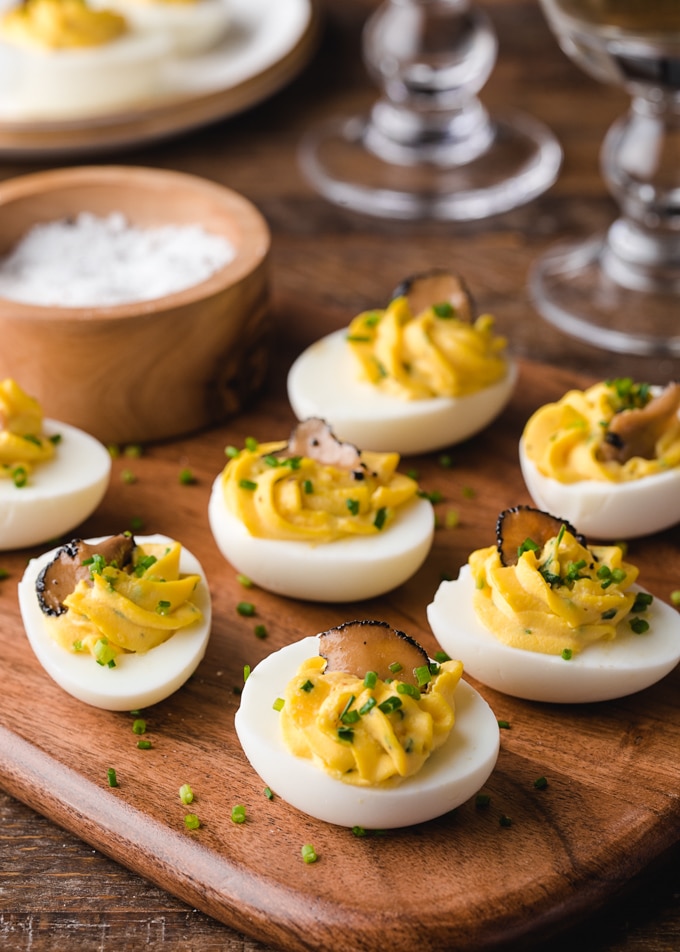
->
(0, 378), (54, 486)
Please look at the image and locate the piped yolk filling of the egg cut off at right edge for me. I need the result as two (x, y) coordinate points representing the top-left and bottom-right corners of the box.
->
(523, 382), (680, 483)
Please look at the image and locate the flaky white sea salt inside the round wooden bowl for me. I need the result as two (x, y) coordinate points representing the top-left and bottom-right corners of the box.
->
(0, 212), (236, 307)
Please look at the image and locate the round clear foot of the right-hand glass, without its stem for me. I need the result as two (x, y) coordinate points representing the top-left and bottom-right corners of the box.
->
(529, 235), (680, 357)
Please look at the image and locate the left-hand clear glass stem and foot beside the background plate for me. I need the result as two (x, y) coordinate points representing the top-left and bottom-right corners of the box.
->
(300, 0), (562, 221)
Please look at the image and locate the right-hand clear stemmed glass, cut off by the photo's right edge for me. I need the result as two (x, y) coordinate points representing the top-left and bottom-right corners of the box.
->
(529, 0), (680, 357)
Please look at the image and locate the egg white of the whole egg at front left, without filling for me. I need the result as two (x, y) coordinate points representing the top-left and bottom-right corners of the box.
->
(19, 535), (211, 711)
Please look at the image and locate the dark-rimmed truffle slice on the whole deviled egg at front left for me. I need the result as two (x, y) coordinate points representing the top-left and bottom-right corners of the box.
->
(35, 533), (135, 615)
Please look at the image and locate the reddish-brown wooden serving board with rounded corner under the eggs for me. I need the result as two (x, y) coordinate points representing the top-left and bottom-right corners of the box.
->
(0, 363), (680, 952)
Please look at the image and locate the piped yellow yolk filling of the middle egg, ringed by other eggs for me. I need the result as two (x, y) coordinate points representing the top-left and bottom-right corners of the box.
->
(222, 442), (418, 542)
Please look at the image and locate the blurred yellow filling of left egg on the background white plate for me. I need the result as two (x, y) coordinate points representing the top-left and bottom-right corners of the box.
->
(0, 0), (128, 50)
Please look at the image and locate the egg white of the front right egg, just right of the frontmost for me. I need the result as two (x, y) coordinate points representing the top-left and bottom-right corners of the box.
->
(427, 565), (680, 704)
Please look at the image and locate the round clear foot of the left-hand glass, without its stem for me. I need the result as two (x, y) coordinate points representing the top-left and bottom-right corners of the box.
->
(299, 113), (562, 221)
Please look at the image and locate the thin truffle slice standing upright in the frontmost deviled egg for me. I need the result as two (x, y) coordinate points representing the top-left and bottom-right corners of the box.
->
(319, 621), (429, 686)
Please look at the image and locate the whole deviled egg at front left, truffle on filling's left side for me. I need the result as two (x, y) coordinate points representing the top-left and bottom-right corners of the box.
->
(19, 533), (211, 711)
